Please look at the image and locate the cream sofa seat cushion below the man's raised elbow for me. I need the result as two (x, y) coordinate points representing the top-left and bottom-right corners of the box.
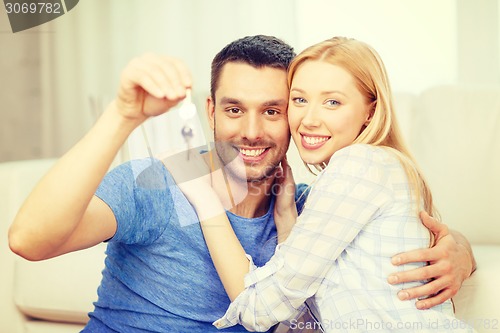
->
(14, 244), (105, 323)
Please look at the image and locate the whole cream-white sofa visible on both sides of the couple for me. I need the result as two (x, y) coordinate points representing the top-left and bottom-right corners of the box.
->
(0, 86), (500, 333)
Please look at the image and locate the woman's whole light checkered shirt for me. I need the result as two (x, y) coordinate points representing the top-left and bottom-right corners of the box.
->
(214, 144), (474, 332)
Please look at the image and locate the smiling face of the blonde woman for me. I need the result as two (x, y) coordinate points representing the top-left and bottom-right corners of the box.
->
(288, 60), (370, 164)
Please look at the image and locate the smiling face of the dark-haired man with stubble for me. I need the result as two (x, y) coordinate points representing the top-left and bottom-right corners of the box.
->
(207, 63), (290, 182)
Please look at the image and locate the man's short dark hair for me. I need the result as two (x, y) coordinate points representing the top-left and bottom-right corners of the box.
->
(210, 35), (295, 102)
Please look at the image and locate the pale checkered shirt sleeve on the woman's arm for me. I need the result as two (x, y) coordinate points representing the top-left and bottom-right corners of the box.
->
(214, 145), (393, 331)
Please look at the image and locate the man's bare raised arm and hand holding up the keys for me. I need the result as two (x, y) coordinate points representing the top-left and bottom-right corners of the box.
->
(9, 55), (191, 260)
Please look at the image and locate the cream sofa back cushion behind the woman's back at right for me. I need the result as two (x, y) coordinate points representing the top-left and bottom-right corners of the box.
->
(411, 85), (500, 245)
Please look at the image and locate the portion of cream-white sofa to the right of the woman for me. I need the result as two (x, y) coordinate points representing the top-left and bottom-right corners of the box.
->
(396, 85), (500, 332)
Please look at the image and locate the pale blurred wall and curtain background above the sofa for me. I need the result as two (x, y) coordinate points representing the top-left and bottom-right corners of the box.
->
(0, 0), (500, 162)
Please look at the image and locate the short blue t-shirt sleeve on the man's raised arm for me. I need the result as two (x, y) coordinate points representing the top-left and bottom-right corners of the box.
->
(95, 158), (173, 245)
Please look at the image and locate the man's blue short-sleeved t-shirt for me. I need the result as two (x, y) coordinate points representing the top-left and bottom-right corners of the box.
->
(83, 159), (307, 333)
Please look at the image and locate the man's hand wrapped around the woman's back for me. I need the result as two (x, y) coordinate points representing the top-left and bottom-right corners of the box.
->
(388, 212), (476, 309)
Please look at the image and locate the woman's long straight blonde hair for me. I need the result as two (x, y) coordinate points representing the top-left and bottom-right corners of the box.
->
(288, 37), (438, 217)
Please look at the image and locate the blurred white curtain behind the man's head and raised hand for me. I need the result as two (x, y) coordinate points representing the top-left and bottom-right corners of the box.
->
(40, 0), (295, 160)
